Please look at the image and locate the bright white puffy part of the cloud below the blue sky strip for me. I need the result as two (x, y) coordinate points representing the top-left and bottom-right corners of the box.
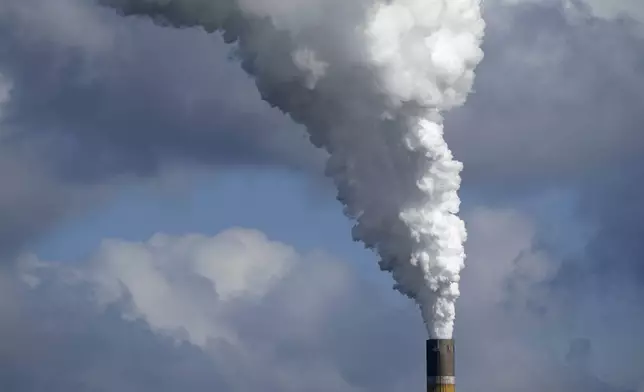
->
(51, 229), (300, 347)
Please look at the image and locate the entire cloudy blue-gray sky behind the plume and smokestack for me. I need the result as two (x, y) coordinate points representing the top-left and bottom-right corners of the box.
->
(0, 0), (644, 392)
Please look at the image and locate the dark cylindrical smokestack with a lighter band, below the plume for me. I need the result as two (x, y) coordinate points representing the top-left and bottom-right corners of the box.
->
(427, 339), (456, 392)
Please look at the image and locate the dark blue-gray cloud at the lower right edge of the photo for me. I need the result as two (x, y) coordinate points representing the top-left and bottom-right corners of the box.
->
(537, 165), (644, 388)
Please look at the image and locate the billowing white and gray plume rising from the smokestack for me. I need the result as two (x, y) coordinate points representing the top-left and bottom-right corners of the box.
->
(100, 0), (484, 338)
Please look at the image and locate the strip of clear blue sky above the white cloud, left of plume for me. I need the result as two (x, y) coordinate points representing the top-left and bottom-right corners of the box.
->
(36, 168), (375, 268)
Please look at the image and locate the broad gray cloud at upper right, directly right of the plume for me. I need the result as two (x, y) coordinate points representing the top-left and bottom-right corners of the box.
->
(447, 0), (644, 188)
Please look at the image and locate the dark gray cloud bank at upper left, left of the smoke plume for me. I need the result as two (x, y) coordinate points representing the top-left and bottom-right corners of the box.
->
(0, 0), (320, 178)
